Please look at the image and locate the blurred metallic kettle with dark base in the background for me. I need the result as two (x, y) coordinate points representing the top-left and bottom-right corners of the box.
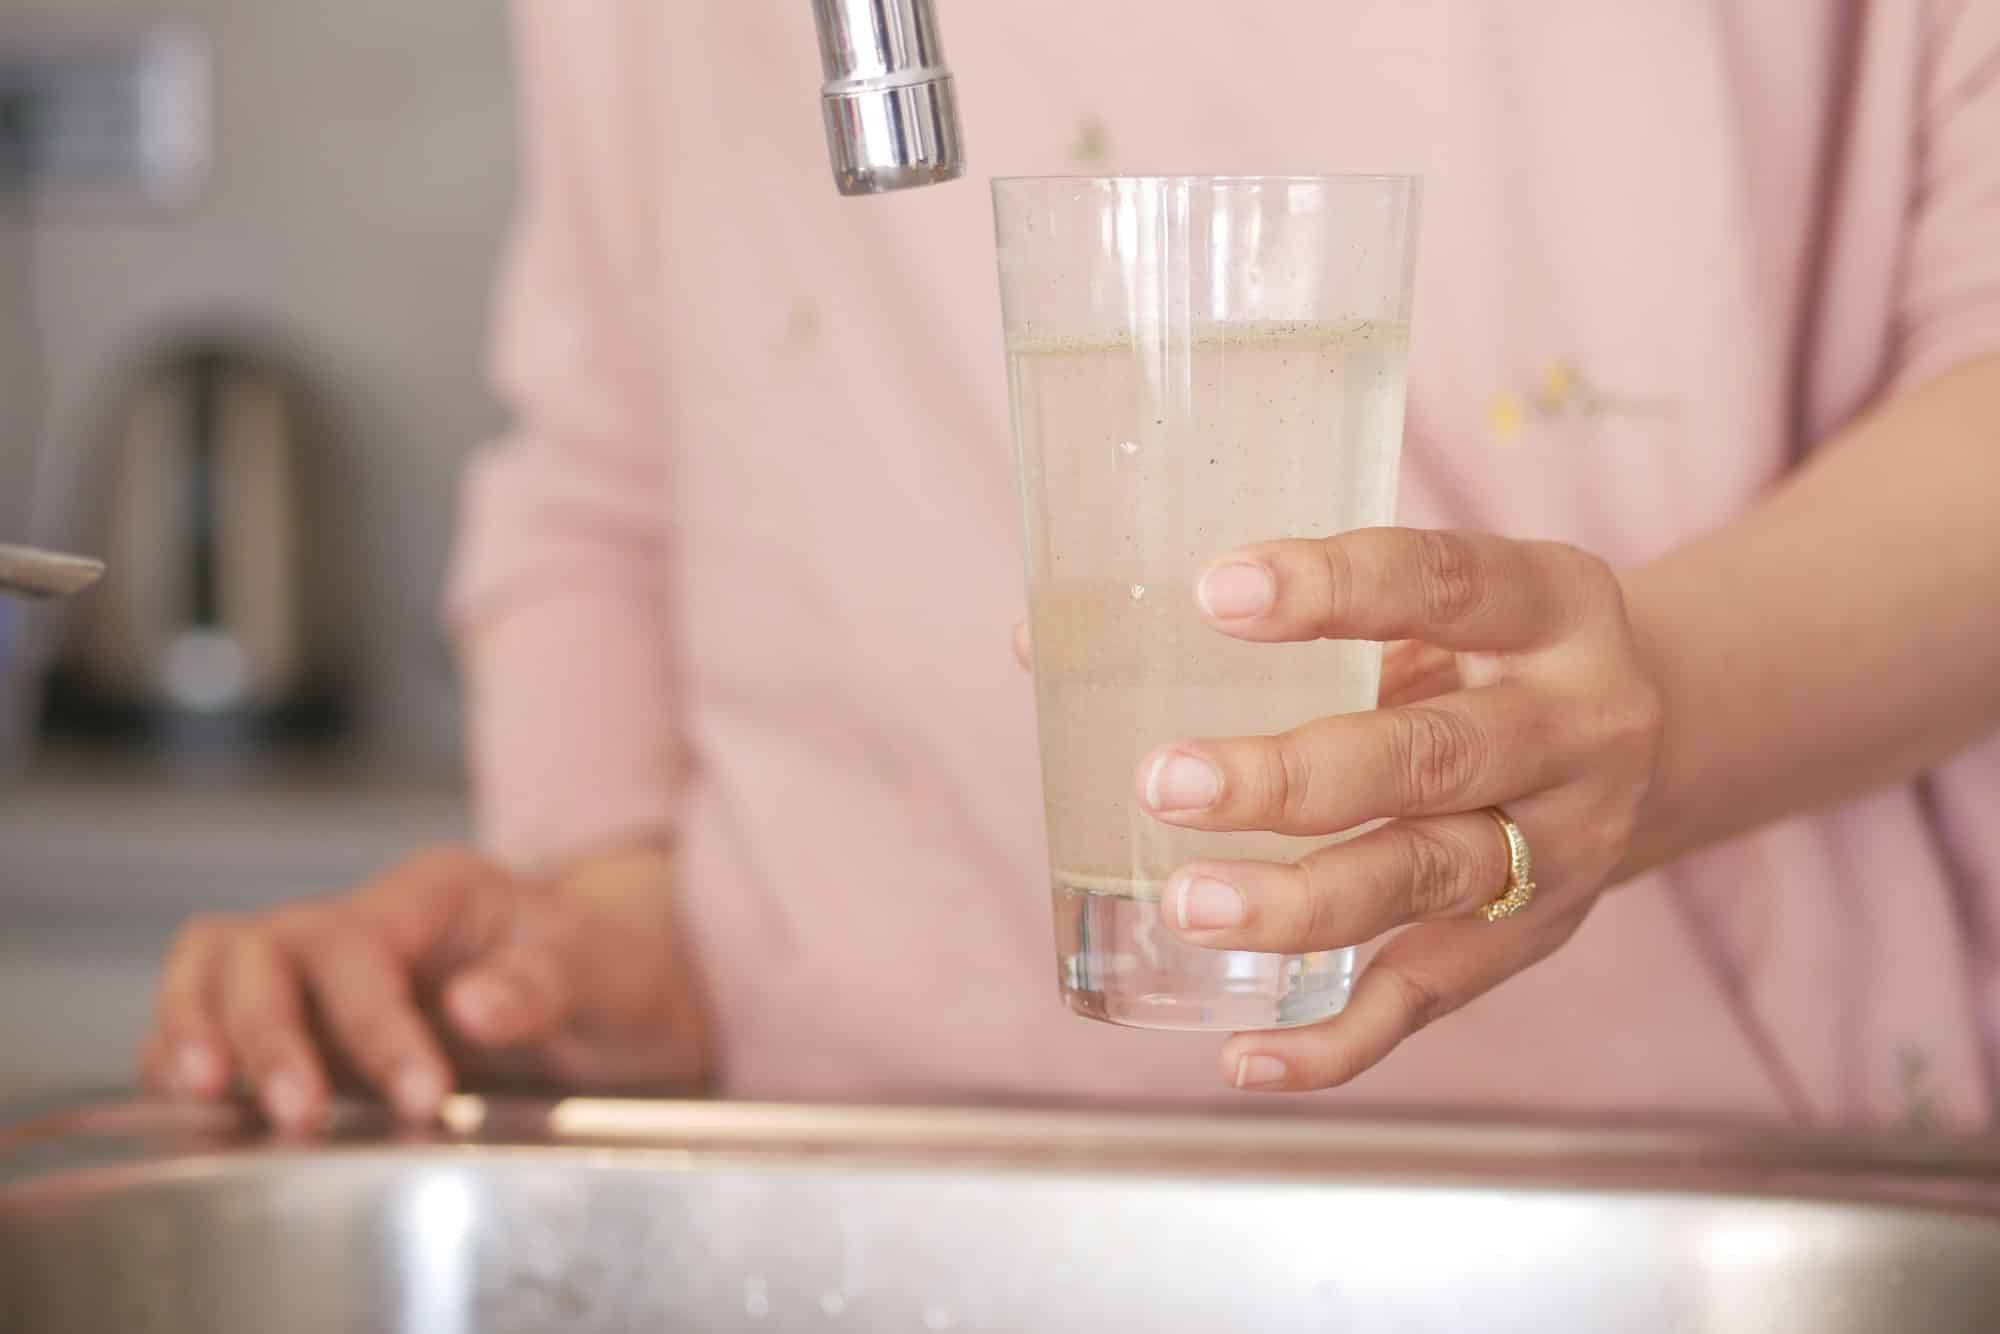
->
(46, 342), (338, 742)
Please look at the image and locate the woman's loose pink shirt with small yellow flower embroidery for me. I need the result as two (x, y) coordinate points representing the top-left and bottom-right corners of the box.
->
(454, 0), (2000, 1124)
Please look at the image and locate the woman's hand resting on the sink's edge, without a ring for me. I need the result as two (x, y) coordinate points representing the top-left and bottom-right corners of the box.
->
(142, 848), (712, 1130)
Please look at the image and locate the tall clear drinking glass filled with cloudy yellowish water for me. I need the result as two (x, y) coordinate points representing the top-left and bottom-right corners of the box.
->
(994, 176), (1418, 1030)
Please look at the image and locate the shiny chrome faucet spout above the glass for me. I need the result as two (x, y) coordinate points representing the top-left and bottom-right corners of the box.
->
(812, 0), (966, 194)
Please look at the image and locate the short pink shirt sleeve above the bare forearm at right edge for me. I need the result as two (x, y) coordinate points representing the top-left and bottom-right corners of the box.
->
(1896, 0), (2000, 388)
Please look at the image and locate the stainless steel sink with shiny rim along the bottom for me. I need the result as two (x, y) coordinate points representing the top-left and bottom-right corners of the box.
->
(0, 1098), (2000, 1334)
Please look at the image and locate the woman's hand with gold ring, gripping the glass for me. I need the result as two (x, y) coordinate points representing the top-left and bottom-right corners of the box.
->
(1138, 528), (1662, 1090)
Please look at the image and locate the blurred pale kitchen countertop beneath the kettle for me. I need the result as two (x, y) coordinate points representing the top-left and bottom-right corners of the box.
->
(0, 752), (470, 924)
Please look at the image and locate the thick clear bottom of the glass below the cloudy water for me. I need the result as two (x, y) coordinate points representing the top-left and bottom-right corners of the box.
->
(1054, 886), (1354, 1032)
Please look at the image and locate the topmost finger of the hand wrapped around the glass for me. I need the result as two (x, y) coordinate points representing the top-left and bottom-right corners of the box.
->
(1196, 528), (1608, 652)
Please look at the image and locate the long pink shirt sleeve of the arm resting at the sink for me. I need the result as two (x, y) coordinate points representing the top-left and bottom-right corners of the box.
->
(448, 0), (680, 868)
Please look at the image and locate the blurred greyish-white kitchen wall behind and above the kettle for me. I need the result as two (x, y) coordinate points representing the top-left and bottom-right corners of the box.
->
(0, 0), (512, 764)
